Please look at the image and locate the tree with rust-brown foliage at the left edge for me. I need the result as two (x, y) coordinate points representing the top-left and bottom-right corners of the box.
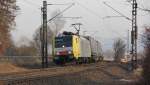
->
(0, 0), (18, 55)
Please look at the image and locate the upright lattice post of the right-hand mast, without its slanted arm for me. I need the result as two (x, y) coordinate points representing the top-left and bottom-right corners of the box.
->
(131, 0), (138, 69)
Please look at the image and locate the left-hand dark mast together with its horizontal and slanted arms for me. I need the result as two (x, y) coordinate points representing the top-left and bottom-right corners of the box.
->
(40, 1), (74, 68)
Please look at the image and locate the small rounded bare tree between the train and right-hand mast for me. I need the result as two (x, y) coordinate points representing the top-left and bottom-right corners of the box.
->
(113, 38), (126, 62)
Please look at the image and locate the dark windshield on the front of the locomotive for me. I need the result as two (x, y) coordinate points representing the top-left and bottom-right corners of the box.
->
(55, 36), (72, 48)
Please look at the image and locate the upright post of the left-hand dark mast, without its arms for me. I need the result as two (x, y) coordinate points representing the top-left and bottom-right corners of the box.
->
(41, 1), (48, 68)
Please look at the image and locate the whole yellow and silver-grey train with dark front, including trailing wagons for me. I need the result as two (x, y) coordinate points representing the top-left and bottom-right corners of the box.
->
(53, 32), (103, 64)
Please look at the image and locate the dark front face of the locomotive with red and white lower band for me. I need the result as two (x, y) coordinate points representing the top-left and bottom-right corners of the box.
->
(53, 35), (73, 64)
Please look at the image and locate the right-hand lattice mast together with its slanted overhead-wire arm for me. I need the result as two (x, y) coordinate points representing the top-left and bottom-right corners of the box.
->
(104, 0), (138, 70)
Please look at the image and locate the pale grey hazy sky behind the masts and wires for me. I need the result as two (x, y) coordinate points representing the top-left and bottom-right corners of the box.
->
(12, 0), (150, 48)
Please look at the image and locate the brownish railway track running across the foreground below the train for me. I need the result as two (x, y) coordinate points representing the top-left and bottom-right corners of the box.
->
(0, 63), (116, 85)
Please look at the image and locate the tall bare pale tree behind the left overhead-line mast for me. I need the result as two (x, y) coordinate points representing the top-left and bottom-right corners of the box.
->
(33, 10), (65, 53)
